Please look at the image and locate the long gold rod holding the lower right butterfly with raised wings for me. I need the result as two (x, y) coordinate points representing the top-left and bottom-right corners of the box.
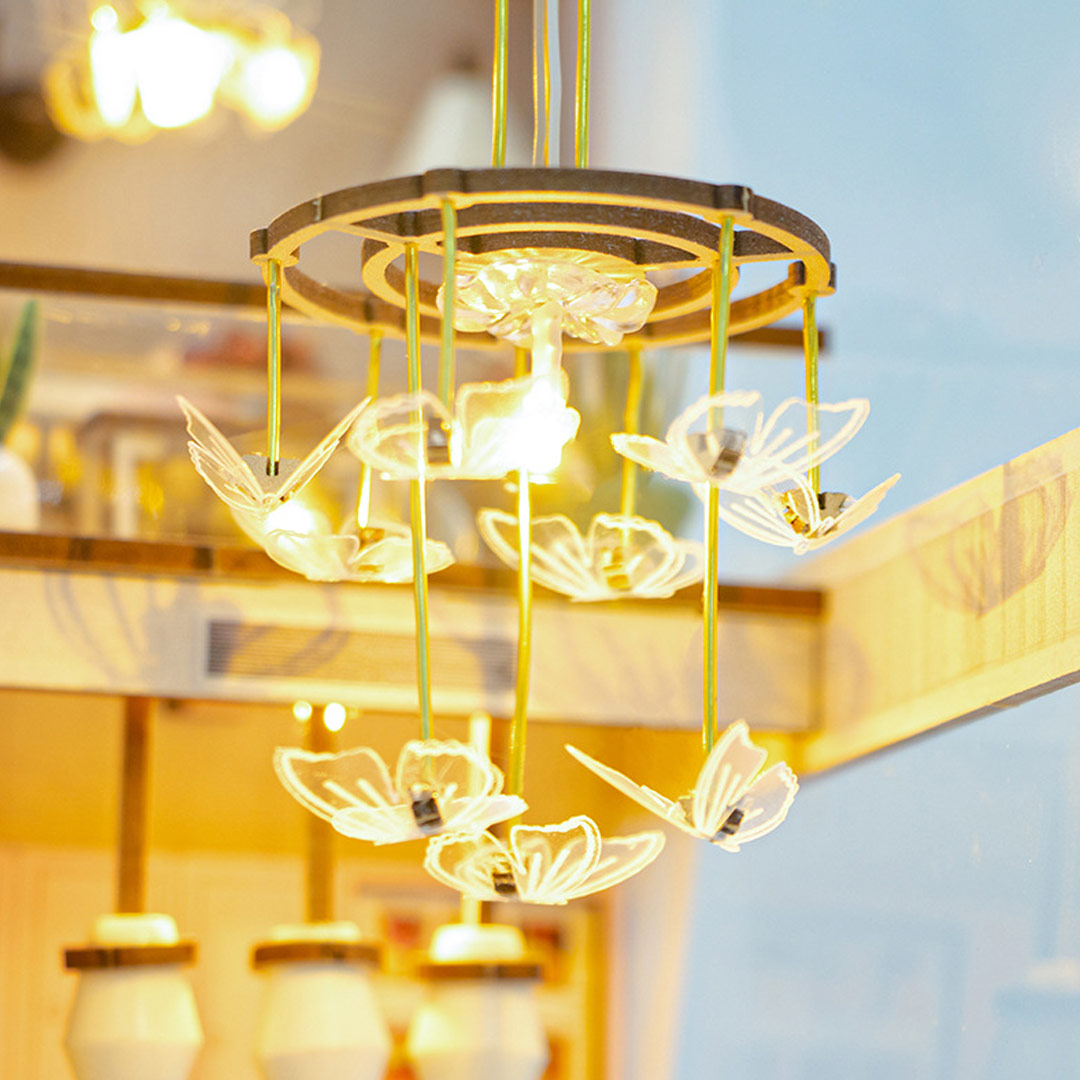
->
(702, 217), (734, 754)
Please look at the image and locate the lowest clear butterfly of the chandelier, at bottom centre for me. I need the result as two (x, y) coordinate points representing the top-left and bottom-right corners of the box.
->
(423, 815), (664, 904)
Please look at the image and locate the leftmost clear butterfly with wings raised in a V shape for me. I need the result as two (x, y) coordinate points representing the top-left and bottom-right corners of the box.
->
(176, 397), (365, 515)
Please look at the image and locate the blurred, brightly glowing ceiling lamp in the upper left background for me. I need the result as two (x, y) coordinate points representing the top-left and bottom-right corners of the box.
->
(43, 0), (319, 143)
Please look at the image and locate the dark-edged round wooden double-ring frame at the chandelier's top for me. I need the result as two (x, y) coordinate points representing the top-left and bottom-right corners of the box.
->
(252, 168), (835, 350)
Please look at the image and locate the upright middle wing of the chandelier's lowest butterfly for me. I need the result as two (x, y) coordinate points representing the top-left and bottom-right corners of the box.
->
(510, 815), (600, 904)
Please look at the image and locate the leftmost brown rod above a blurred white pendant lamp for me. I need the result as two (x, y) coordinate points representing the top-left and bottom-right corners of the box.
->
(117, 698), (153, 915)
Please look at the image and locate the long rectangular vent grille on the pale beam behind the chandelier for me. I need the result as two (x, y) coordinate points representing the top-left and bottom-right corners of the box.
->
(206, 620), (515, 690)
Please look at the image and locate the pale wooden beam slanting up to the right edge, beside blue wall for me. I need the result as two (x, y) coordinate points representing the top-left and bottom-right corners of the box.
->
(797, 430), (1080, 772)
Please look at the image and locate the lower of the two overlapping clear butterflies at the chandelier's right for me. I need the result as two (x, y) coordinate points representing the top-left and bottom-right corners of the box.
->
(719, 473), (900, 555)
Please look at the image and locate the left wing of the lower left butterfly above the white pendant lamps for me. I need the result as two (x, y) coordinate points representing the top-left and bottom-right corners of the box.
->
(273, 746), (401, 821)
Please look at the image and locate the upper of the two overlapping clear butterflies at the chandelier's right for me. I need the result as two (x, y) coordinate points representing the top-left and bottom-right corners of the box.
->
(611, 390), (870, 495)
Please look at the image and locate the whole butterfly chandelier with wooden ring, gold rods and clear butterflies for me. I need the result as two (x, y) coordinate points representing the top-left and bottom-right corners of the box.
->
(174, 0), (899, 904)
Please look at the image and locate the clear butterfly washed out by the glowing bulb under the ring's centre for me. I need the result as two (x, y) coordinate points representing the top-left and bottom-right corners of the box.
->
(348, 372), (581, 480)
